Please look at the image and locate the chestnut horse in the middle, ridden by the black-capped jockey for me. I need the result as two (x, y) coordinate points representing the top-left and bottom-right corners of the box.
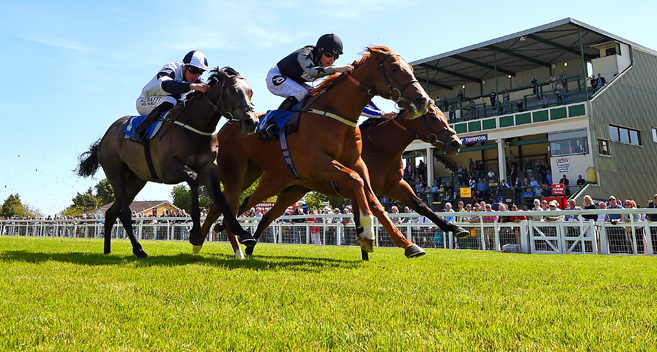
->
(203, 46), (430, 257)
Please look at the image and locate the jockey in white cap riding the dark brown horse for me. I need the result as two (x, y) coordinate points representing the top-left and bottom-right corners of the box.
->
(130, 50), (210, 143)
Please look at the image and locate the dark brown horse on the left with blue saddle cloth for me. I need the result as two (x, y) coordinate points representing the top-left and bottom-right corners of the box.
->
(76, 68), (258, 258)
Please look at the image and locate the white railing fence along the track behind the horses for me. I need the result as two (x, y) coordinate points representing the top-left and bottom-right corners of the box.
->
(0, 209), (657, 255)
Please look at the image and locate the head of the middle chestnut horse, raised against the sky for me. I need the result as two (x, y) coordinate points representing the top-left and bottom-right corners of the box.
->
(361, 46), (430, 116)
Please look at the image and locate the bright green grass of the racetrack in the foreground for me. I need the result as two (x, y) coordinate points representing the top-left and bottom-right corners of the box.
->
(0, 237), (657, 351)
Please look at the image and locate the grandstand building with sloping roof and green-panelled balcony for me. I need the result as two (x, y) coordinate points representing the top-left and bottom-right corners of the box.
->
(404, 18), (657, 207)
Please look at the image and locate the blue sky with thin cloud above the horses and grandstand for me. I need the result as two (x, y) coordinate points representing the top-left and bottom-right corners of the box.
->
(0, 0), (657, 215)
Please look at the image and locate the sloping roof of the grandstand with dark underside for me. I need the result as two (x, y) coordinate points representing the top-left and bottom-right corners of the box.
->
(410, 17), (657, 89)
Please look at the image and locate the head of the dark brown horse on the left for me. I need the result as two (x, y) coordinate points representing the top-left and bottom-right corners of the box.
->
(208, 67), (258, 135)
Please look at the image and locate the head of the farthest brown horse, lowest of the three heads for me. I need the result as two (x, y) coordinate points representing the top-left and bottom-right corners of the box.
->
(395, 104), (462, 155)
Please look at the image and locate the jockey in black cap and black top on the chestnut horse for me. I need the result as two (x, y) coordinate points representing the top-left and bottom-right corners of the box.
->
(265, 33), (354, 110)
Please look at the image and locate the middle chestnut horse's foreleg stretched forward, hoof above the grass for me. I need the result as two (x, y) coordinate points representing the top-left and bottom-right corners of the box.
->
(353, 158), (425, 258)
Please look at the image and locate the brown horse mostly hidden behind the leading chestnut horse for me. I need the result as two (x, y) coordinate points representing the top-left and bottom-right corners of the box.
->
(209, 105), (469, 255)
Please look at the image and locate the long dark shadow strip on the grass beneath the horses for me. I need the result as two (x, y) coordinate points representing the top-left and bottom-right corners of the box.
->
(0, 250), (362, 272)
